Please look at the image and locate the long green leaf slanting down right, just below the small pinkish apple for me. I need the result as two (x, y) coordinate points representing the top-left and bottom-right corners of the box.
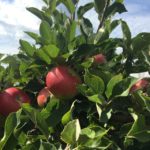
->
(22, 104), (49, 139)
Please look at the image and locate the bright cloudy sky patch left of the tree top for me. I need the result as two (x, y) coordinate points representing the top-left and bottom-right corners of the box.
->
(0, 0), (44, 54)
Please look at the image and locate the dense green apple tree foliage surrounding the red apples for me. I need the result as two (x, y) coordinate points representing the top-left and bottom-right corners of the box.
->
(0, 0), (150, 150)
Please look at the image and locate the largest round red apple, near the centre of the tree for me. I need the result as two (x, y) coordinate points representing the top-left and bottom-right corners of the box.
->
(46, 66), (81, 99)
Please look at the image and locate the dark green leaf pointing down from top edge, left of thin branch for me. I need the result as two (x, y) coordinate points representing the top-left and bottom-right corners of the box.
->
(94, 0), (106, 15)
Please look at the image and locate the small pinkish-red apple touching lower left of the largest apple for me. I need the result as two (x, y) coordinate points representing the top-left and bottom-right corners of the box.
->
(37, 87), (51, 107)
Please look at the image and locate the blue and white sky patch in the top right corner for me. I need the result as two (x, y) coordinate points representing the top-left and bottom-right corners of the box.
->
(112, 0), (150, 36)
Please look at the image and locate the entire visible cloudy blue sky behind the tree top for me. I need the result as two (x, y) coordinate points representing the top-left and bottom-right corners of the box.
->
(0, 0), (150, 54)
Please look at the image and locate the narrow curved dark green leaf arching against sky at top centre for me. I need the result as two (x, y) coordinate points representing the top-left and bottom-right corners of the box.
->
(77, 3), (94, 19)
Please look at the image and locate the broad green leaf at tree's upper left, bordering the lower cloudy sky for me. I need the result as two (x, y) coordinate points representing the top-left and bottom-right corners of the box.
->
(20, 40), (36, 57)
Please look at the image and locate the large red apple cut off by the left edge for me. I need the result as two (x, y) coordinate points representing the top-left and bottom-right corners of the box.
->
(0, 87), (31, 116)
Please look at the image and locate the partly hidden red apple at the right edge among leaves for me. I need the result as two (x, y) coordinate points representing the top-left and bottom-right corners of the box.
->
(130, 79), (149, 93)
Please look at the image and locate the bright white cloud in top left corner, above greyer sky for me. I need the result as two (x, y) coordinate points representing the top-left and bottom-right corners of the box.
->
(0, 0), (43, 29)
